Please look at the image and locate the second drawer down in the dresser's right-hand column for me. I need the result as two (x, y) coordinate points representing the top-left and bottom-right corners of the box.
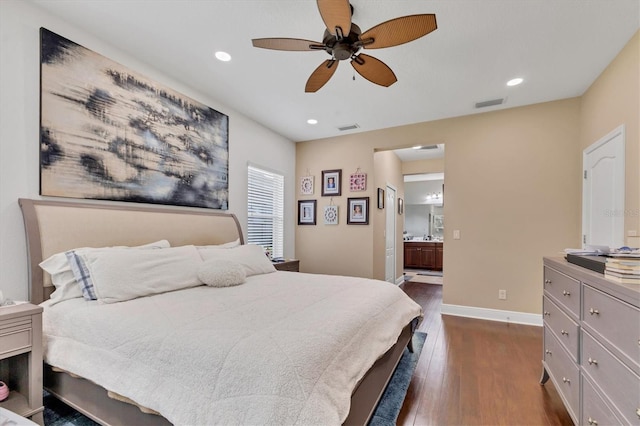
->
(582, 330), (640, 424)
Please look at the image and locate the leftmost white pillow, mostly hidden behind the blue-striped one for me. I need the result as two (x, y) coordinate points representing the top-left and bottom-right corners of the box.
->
(40, 240), (171, 305)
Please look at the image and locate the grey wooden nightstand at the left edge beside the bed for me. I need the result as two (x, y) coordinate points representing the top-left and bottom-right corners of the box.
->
(0, 303), (44, 424)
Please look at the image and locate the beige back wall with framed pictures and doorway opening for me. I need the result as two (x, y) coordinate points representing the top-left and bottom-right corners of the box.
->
(296, 98), (580, 313)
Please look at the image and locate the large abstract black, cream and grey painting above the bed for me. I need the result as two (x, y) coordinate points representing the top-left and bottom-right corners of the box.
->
(40, 28), (229, 210)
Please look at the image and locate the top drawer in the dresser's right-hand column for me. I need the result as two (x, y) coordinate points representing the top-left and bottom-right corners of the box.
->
(582, 285), (640, 374)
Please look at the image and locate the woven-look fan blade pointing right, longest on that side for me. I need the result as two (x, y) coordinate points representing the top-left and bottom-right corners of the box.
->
(360, 14), (438, 49)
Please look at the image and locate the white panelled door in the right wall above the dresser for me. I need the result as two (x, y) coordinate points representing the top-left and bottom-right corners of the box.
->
(582, 125), (624, 247)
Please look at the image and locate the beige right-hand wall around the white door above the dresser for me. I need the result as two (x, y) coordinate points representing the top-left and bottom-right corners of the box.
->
(580, 31), (640, 247)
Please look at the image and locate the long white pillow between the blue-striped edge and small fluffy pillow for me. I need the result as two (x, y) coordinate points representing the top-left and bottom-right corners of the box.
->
(81, 246), (202, 303)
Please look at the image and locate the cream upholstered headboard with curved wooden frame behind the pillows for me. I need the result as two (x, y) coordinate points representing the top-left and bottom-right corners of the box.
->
(19, 198), (244, 304)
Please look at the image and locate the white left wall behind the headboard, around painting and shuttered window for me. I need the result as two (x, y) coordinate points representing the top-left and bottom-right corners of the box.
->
(0, 0), (296, 300)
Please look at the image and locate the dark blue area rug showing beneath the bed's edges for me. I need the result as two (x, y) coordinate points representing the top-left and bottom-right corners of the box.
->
(43, 331), (427, 426)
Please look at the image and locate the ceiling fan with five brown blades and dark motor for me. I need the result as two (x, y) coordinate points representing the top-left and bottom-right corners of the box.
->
(252, 0), (438, 92)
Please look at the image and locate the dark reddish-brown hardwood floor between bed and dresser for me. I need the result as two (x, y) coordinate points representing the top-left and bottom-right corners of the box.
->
(397, 281), (573, 425)
